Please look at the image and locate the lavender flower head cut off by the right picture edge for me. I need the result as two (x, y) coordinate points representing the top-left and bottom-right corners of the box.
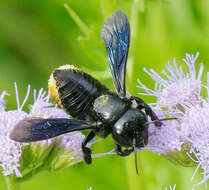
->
(182, 86), (209, 185)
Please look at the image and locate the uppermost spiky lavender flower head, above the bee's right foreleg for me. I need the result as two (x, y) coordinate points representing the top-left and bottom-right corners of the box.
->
(137, 53), (203, 109)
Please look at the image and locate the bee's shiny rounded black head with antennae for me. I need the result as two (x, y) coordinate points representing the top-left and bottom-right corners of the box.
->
(112, 109), (148, 148)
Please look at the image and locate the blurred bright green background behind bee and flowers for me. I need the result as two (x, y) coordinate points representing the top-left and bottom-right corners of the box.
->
(0, 0), (209, 190)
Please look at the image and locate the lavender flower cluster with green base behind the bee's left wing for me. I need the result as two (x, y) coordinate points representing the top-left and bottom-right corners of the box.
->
(0, 84), (85, 177)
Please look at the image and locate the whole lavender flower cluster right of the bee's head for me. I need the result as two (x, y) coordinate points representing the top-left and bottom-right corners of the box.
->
(137, 53), (209, 185)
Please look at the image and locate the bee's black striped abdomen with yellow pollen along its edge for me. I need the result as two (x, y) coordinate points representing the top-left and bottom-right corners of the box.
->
(49, 65), (108, 118)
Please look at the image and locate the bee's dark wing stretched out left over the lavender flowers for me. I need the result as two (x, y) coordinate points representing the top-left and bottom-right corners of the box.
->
(10, 118), (94, 142)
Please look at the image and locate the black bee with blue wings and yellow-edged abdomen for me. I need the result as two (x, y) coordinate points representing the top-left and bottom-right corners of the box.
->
(10, 11), (164, 174)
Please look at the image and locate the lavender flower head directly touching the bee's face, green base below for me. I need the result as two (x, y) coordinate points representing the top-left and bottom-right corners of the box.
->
(146, 107), (194, 166)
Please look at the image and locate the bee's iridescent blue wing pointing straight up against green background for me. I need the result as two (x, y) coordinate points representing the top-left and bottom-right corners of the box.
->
(101, 11), (130, 97)
